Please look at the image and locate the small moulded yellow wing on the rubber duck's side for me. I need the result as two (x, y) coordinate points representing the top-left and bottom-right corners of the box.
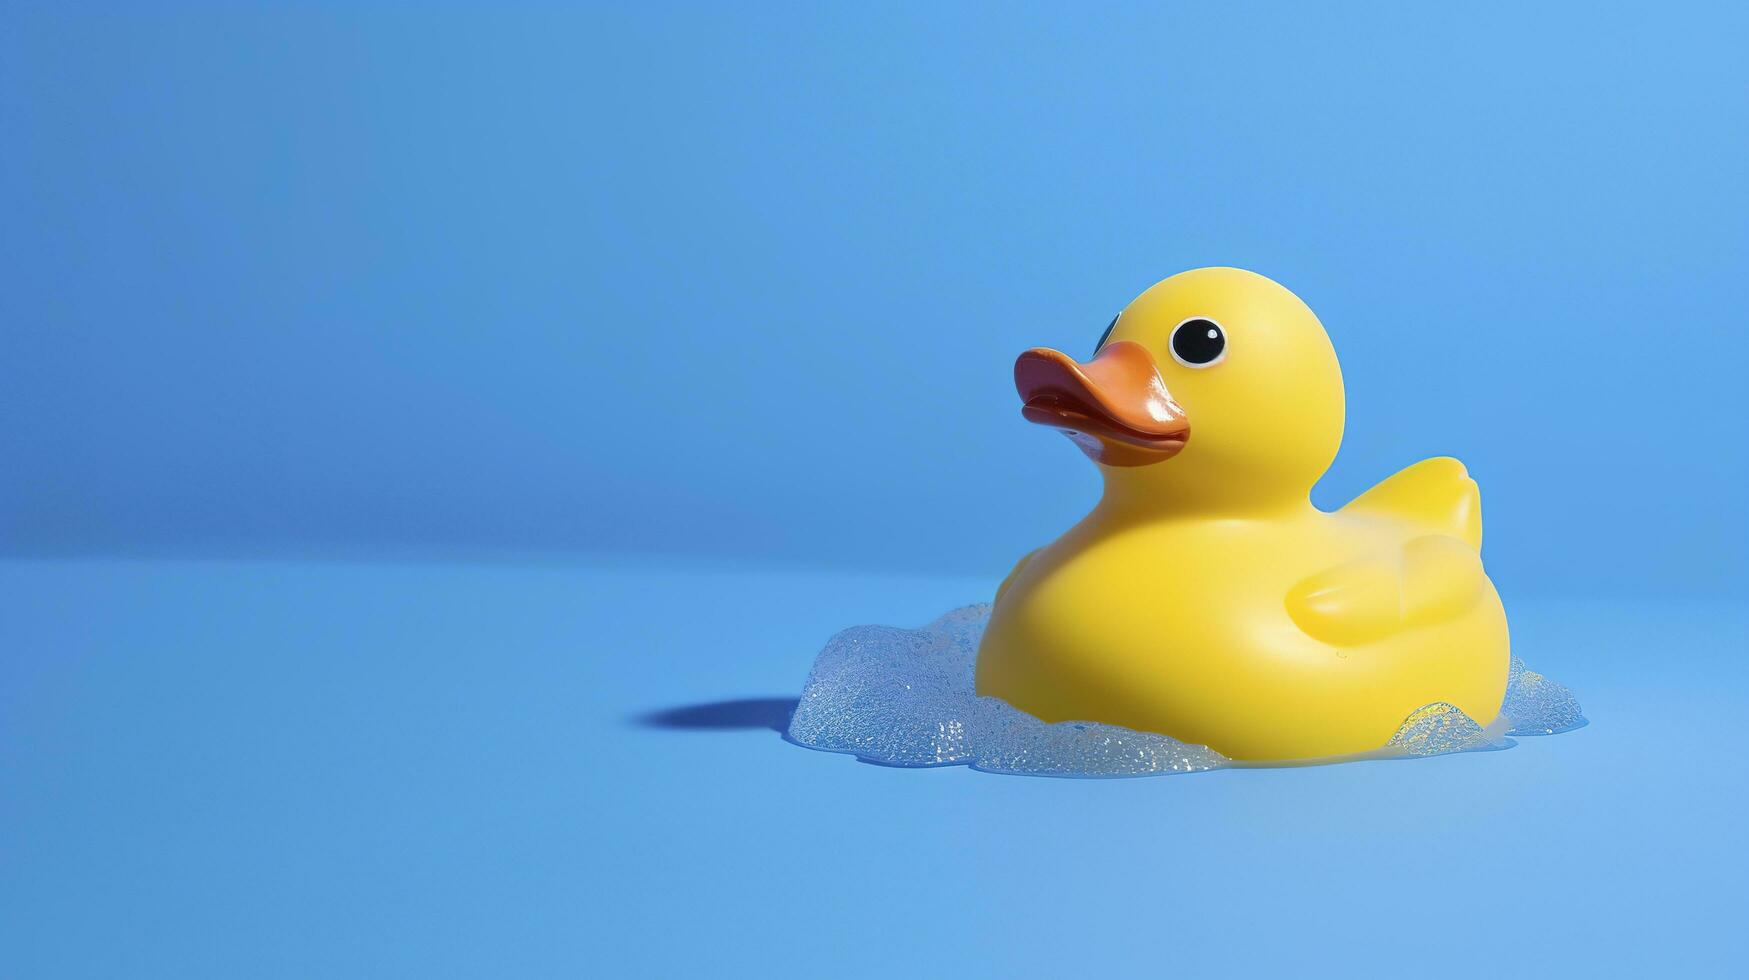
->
(1287, 534), (1487, 646)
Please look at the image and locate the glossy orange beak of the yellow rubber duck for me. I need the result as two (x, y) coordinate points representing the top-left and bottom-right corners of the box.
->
(1014, 341), (1191, 466)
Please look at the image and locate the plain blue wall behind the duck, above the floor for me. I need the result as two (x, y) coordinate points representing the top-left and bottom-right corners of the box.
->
(0, 2), (1749, 595)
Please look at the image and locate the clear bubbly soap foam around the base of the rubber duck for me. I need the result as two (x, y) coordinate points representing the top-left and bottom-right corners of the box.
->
(789, 604), (1585, 777)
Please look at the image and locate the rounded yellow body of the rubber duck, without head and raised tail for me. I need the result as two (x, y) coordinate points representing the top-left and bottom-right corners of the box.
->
(978, 460), (1508, 760)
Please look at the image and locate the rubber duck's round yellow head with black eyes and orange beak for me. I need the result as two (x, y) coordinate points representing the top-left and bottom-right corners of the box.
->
(1014, 268), (1343, 509)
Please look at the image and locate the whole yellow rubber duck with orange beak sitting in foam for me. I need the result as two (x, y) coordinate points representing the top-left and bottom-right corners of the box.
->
(978, 268), (1509, 760)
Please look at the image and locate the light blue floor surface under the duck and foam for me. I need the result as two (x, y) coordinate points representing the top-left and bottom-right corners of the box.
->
(0, 562), (1749, 978)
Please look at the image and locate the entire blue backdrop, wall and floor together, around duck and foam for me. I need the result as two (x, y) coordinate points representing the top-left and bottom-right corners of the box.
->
(0, 4), (1749, 977)
